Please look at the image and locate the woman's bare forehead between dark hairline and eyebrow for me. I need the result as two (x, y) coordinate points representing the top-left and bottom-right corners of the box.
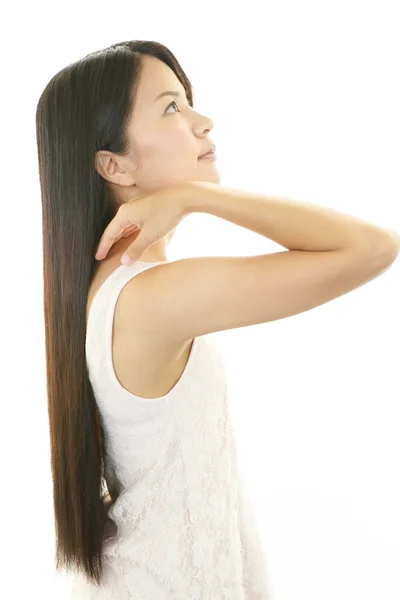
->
(137, 55), (185, 106)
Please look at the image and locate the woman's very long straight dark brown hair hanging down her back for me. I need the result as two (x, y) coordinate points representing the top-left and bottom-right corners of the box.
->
(36, 40), (193, 585)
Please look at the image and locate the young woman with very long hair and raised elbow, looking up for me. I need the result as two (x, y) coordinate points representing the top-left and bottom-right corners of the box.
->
(36, 40), (399, 600)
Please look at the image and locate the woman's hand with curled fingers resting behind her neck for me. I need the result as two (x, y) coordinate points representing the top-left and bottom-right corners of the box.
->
(95, 183), (190, 264)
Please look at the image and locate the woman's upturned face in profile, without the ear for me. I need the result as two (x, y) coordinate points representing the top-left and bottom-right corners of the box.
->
(123, 55), (220, 195)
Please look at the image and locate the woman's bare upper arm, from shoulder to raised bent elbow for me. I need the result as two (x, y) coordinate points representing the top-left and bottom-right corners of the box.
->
(126, 249), (391, 344)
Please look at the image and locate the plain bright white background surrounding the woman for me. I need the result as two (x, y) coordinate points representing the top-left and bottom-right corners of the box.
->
(0, 0), (400, 600)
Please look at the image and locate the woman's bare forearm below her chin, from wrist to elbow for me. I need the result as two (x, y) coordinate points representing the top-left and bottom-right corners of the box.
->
(189, 181), (395, 253)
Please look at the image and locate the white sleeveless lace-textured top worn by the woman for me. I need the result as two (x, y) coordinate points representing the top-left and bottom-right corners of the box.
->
(71, 262), (272, 600)
